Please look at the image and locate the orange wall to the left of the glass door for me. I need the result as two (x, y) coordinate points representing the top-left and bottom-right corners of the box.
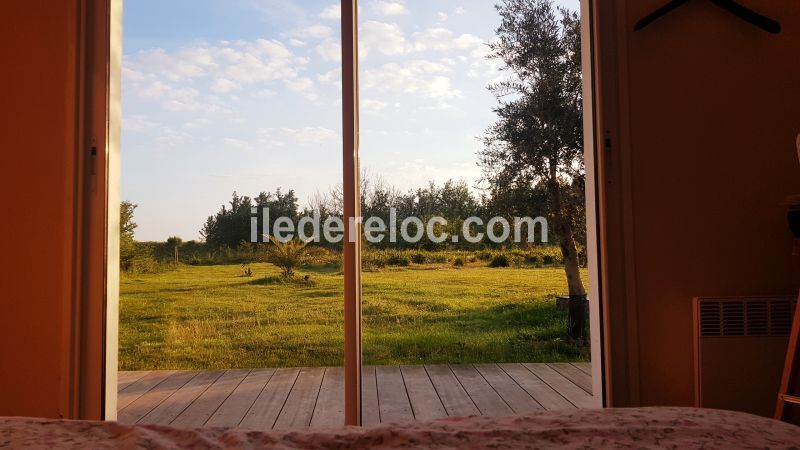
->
(0, 0), (77, 417)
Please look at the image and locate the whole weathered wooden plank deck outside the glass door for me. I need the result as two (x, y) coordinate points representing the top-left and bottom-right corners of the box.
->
(118, 363), (594, 430)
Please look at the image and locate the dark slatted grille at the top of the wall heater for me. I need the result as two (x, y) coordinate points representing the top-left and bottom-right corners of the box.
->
(699, 298), (797, 336)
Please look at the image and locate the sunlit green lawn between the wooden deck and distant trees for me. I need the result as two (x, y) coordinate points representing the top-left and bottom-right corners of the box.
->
(120, 264), (588, 370)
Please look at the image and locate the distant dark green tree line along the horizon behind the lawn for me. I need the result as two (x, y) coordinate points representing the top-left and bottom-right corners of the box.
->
(200, 175), (582, 250)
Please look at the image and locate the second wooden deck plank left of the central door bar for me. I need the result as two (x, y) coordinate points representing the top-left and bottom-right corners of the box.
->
(273, 367), (325, 430)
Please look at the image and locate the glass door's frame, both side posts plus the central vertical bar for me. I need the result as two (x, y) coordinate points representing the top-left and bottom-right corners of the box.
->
(84, 0), (612, 425)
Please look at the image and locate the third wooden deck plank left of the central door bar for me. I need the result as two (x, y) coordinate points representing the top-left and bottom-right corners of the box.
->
(239, 368), (300, 430)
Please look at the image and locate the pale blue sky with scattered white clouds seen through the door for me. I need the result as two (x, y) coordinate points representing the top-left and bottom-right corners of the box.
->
(122, 0), (578, 241)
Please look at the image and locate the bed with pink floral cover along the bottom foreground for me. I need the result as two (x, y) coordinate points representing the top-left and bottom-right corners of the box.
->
(0, 408), (800, 450)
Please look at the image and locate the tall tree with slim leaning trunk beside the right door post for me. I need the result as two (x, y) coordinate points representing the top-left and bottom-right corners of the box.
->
(480, 0), (586, 294)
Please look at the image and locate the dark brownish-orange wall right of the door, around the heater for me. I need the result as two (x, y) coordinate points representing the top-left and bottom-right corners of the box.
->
(599, 0), (800, 405)
